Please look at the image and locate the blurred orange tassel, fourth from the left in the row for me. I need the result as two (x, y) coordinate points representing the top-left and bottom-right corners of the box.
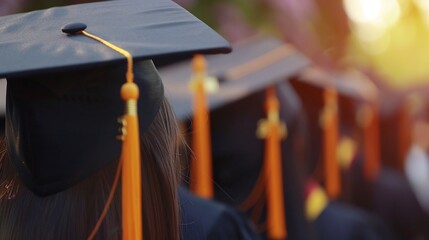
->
(321, 88), (341, 199)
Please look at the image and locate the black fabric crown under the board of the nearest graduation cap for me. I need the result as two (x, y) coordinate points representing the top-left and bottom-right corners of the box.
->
(6, 61), (164, 196)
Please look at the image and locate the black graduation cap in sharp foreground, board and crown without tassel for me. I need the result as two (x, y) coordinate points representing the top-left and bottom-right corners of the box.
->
(0, 0), (230, 195)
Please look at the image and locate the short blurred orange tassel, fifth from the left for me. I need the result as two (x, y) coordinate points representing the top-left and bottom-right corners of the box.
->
(358, 103), (380, 181)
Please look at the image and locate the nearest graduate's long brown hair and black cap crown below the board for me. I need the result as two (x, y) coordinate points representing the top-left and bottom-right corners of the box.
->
(0, 61), (179, 239)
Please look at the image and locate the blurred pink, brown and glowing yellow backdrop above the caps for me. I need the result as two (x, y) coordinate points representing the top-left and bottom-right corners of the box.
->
(5, 0), (429, 90)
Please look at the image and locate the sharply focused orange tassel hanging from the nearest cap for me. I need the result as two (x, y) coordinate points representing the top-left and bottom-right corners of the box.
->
(121, 82), (143, 240)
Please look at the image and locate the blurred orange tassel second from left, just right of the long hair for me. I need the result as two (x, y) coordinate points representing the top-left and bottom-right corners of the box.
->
(190, 55), (213, 198)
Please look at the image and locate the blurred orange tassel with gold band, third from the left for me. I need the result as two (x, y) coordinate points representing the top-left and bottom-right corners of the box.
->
(257, 87), (287, 239)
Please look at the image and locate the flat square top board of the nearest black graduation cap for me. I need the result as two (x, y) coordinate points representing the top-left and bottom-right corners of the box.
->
(0, 0), (231, 78)
